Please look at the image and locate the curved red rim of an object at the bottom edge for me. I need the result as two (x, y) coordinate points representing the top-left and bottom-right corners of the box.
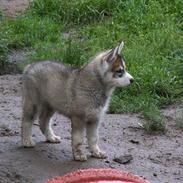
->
(45, 169), (150, 183)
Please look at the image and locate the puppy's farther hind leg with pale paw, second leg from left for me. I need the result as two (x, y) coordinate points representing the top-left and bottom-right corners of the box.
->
(39, 104), (60, 143)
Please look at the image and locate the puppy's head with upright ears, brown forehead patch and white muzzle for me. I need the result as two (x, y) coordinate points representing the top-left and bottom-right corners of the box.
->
(102, 42), (134, 87)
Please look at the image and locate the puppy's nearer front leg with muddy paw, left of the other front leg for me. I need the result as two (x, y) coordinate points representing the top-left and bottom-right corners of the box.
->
(72, 117), (87, 161)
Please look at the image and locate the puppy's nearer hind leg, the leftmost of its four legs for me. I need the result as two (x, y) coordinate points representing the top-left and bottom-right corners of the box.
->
(22, 97), (37, 147)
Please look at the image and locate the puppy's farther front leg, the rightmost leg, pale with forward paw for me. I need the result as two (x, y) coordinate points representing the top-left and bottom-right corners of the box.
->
(86, 120), (107, 159)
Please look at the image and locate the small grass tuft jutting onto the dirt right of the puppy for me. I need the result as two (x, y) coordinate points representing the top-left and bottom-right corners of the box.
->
(143, 107), (166, 133)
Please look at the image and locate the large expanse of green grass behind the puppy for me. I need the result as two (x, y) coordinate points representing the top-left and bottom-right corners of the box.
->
(0, 0), (183, 116)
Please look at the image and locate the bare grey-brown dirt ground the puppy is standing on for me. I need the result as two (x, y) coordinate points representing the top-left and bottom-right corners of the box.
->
(0, 75), (183, 183)
